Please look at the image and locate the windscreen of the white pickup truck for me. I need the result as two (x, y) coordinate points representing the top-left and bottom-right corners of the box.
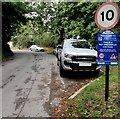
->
(65, 41), (91, 48)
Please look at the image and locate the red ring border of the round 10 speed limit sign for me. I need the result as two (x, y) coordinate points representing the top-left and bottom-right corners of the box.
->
(95, 2), (120, 30)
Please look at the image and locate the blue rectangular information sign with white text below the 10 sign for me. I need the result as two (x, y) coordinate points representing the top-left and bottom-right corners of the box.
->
(98, 32), (118, 66)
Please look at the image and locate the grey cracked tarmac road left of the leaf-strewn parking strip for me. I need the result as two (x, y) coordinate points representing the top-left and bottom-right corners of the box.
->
(0, 51), (55, 117)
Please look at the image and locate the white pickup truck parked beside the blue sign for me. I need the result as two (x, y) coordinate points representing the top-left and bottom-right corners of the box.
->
(56, 39), (100, 77)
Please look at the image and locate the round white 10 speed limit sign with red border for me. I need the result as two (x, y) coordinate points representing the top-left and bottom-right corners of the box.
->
(95, 2), (120, 30)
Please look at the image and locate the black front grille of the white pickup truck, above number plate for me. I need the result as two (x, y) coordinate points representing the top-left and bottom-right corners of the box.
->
(71, 56), (96, 62)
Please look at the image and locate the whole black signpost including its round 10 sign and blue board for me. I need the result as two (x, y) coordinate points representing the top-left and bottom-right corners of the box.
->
(95, 1), (120, 101)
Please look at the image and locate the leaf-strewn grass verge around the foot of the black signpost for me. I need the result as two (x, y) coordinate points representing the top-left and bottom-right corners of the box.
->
(65, 61), (120, 118)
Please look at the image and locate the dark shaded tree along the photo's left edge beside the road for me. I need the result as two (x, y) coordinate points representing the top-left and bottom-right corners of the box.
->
(2, 2), (29, 57)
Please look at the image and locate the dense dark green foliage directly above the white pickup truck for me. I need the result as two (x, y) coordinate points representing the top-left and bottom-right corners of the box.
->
(49, 2), (99, 44)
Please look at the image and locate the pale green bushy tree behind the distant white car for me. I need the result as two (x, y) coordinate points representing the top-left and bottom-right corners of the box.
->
(12, 20), (56, 49)
